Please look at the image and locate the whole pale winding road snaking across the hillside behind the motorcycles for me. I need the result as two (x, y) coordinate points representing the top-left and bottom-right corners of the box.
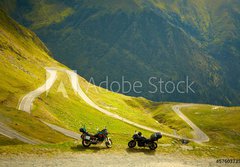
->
(18, 68), (209, 143)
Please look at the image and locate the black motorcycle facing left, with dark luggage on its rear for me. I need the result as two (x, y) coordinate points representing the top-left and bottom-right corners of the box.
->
(128, 132), (162, 150)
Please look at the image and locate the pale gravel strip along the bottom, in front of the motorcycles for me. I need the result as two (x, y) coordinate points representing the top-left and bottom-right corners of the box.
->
(0, 153), (217, 167)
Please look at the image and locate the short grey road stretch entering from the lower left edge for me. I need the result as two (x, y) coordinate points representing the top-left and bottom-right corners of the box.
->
(0, 122), (41, 144)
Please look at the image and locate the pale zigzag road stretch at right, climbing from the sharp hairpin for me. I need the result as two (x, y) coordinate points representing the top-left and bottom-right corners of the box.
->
(172, 104), (209, 143)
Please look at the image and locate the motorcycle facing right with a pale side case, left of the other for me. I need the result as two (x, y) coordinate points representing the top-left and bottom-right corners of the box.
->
(80, 127), (112, 148)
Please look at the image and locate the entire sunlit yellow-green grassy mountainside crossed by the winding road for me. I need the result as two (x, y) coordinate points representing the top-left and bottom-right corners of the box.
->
(0, 10), (240, 158)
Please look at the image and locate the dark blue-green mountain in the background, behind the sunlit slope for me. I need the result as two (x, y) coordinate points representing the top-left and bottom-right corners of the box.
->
(0, 0), (240, 105)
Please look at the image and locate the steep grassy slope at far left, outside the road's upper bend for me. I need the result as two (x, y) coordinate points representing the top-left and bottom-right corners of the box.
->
(0, 11), (72, 143)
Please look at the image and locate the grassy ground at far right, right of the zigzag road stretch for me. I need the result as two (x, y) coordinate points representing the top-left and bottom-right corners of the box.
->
(182, 105), (240, 157)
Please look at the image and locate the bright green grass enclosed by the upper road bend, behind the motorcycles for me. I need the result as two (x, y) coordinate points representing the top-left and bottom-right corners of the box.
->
(33, 73), (156, 145)
